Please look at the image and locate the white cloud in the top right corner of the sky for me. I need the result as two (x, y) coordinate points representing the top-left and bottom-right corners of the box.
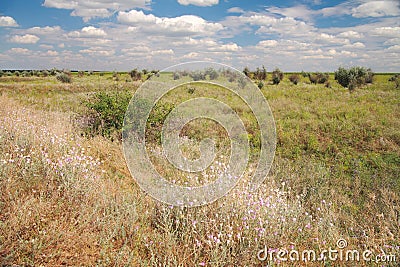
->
(352, 1), (400, 18)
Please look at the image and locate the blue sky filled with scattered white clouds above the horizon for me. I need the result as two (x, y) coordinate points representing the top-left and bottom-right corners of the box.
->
(0, 0), (400, 72)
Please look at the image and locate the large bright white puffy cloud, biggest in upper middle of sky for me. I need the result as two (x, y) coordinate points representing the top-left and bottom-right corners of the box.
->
(117, 10), (223, 35)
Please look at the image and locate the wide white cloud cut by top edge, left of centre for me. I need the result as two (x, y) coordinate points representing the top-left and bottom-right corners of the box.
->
(43, 0), (151, 21)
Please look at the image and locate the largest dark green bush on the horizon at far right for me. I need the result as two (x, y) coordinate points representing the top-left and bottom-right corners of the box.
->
(335, 67), (374, 91)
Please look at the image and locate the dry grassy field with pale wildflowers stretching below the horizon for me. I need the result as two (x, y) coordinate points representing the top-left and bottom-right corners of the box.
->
(0, 73), (400, 266)
